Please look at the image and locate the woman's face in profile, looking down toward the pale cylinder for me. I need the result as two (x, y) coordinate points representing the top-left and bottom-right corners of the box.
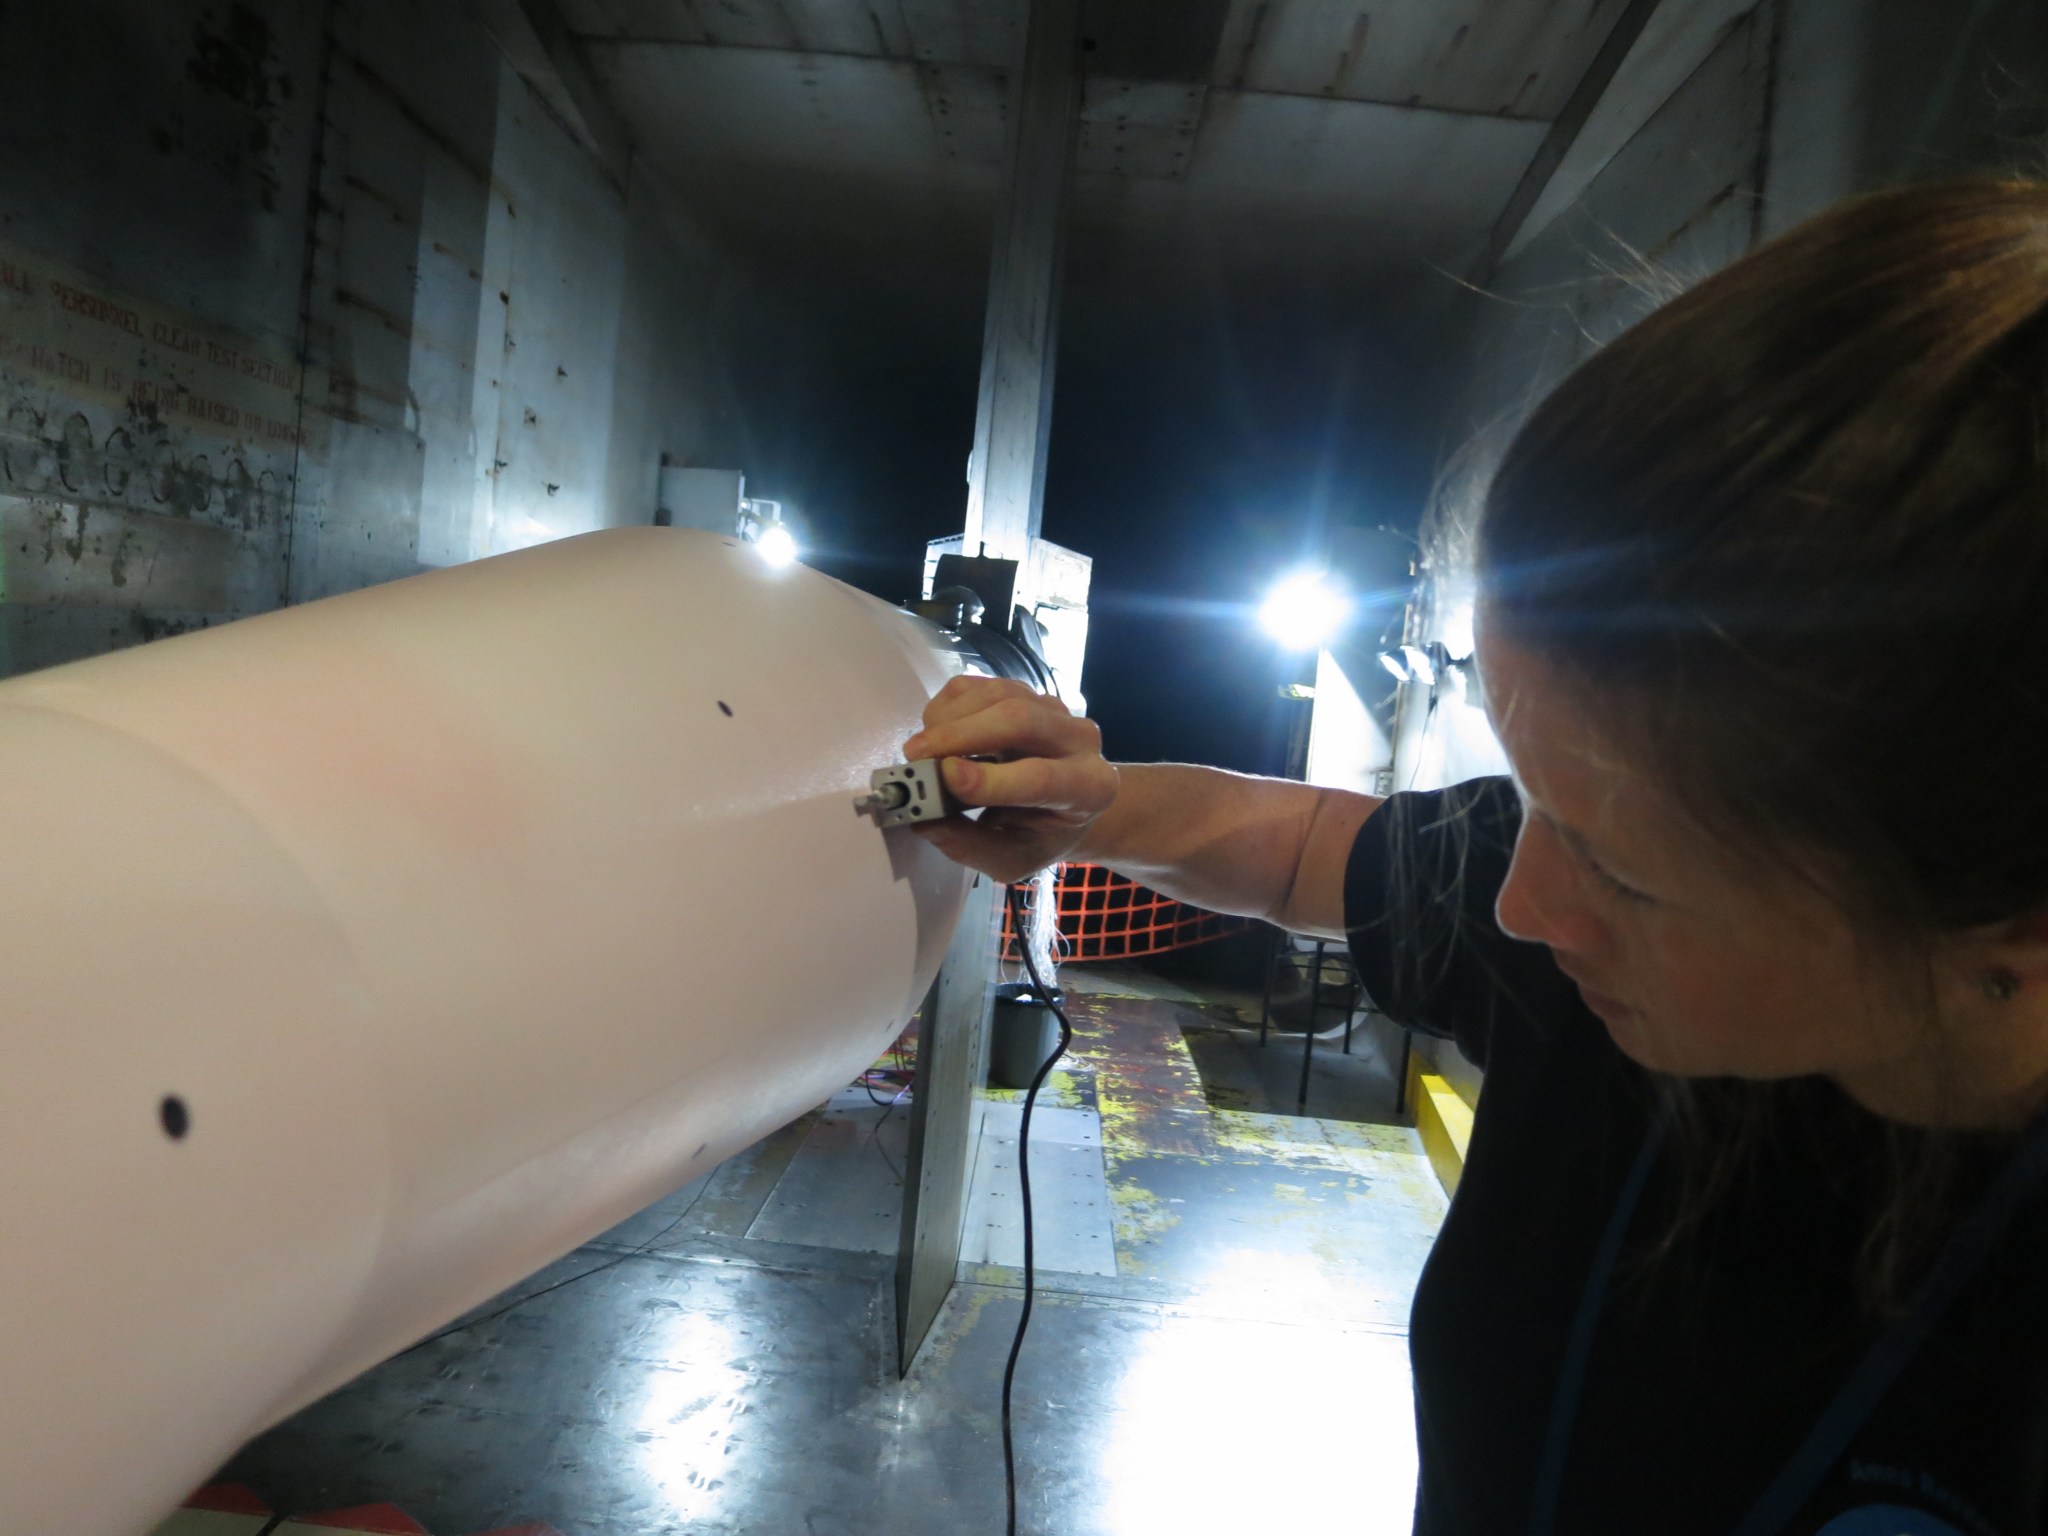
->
(1479, 629), (1925, 1092)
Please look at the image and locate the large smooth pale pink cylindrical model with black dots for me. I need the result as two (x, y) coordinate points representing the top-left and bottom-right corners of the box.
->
(0, 528), (967, 1536)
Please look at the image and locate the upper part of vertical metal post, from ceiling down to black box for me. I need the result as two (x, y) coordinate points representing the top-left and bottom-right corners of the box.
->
(965, 0), (1081, 573)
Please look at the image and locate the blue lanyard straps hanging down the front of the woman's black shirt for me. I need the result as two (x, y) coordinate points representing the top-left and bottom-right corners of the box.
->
(1528, 1118), (2048, 1536)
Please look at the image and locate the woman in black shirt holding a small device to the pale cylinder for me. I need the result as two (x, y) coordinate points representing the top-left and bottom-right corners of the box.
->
(905, 184), (2048, 1536)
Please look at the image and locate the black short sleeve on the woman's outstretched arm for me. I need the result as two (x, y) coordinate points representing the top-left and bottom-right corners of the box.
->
(1343, 778), (1583, 1067)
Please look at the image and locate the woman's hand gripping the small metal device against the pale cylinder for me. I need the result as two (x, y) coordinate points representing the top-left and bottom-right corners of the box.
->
(903, 678), (1116, 881)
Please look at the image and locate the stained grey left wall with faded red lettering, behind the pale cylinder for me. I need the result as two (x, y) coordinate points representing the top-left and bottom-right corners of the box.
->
(0, 0), (735, 672)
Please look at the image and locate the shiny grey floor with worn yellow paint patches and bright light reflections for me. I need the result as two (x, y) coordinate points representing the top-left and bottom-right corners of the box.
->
(203, 973), (1444, 1536)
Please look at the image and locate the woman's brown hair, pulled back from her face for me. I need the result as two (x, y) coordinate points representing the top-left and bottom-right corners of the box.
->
(1477, 180), (2048, 1292)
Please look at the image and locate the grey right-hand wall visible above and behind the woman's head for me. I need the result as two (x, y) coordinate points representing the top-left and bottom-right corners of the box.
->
(1397, 0), (2048, 786)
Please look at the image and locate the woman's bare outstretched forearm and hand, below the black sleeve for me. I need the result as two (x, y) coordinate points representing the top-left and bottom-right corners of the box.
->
(903, 678), (1380, 938)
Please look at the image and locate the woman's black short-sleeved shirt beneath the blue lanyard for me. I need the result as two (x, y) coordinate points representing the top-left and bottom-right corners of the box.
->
(1346, 778), (2048, 1536)
